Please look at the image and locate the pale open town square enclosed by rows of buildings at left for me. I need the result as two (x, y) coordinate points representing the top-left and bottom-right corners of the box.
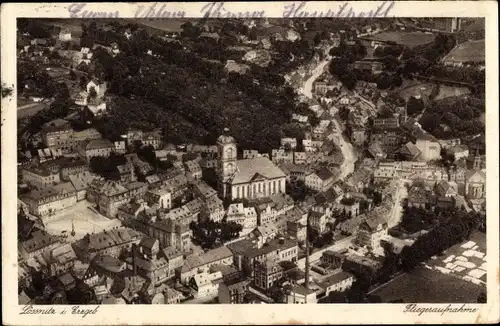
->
(45, 200), (121, 239)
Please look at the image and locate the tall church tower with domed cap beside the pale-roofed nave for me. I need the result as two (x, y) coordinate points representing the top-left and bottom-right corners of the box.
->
(217, 128), (237, 198)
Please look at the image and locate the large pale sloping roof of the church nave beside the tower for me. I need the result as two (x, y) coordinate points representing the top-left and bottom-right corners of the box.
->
(231, 157), (285, 184)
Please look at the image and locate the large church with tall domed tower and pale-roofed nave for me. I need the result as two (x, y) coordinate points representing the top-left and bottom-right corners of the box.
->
(217, 128), (286, 199)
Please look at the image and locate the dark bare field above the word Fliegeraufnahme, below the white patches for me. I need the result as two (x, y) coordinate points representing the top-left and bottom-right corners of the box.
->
(371, 267), (485, 303)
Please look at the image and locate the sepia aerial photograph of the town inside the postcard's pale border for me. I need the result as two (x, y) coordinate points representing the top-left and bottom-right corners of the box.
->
(16, 17), (487, 305)
